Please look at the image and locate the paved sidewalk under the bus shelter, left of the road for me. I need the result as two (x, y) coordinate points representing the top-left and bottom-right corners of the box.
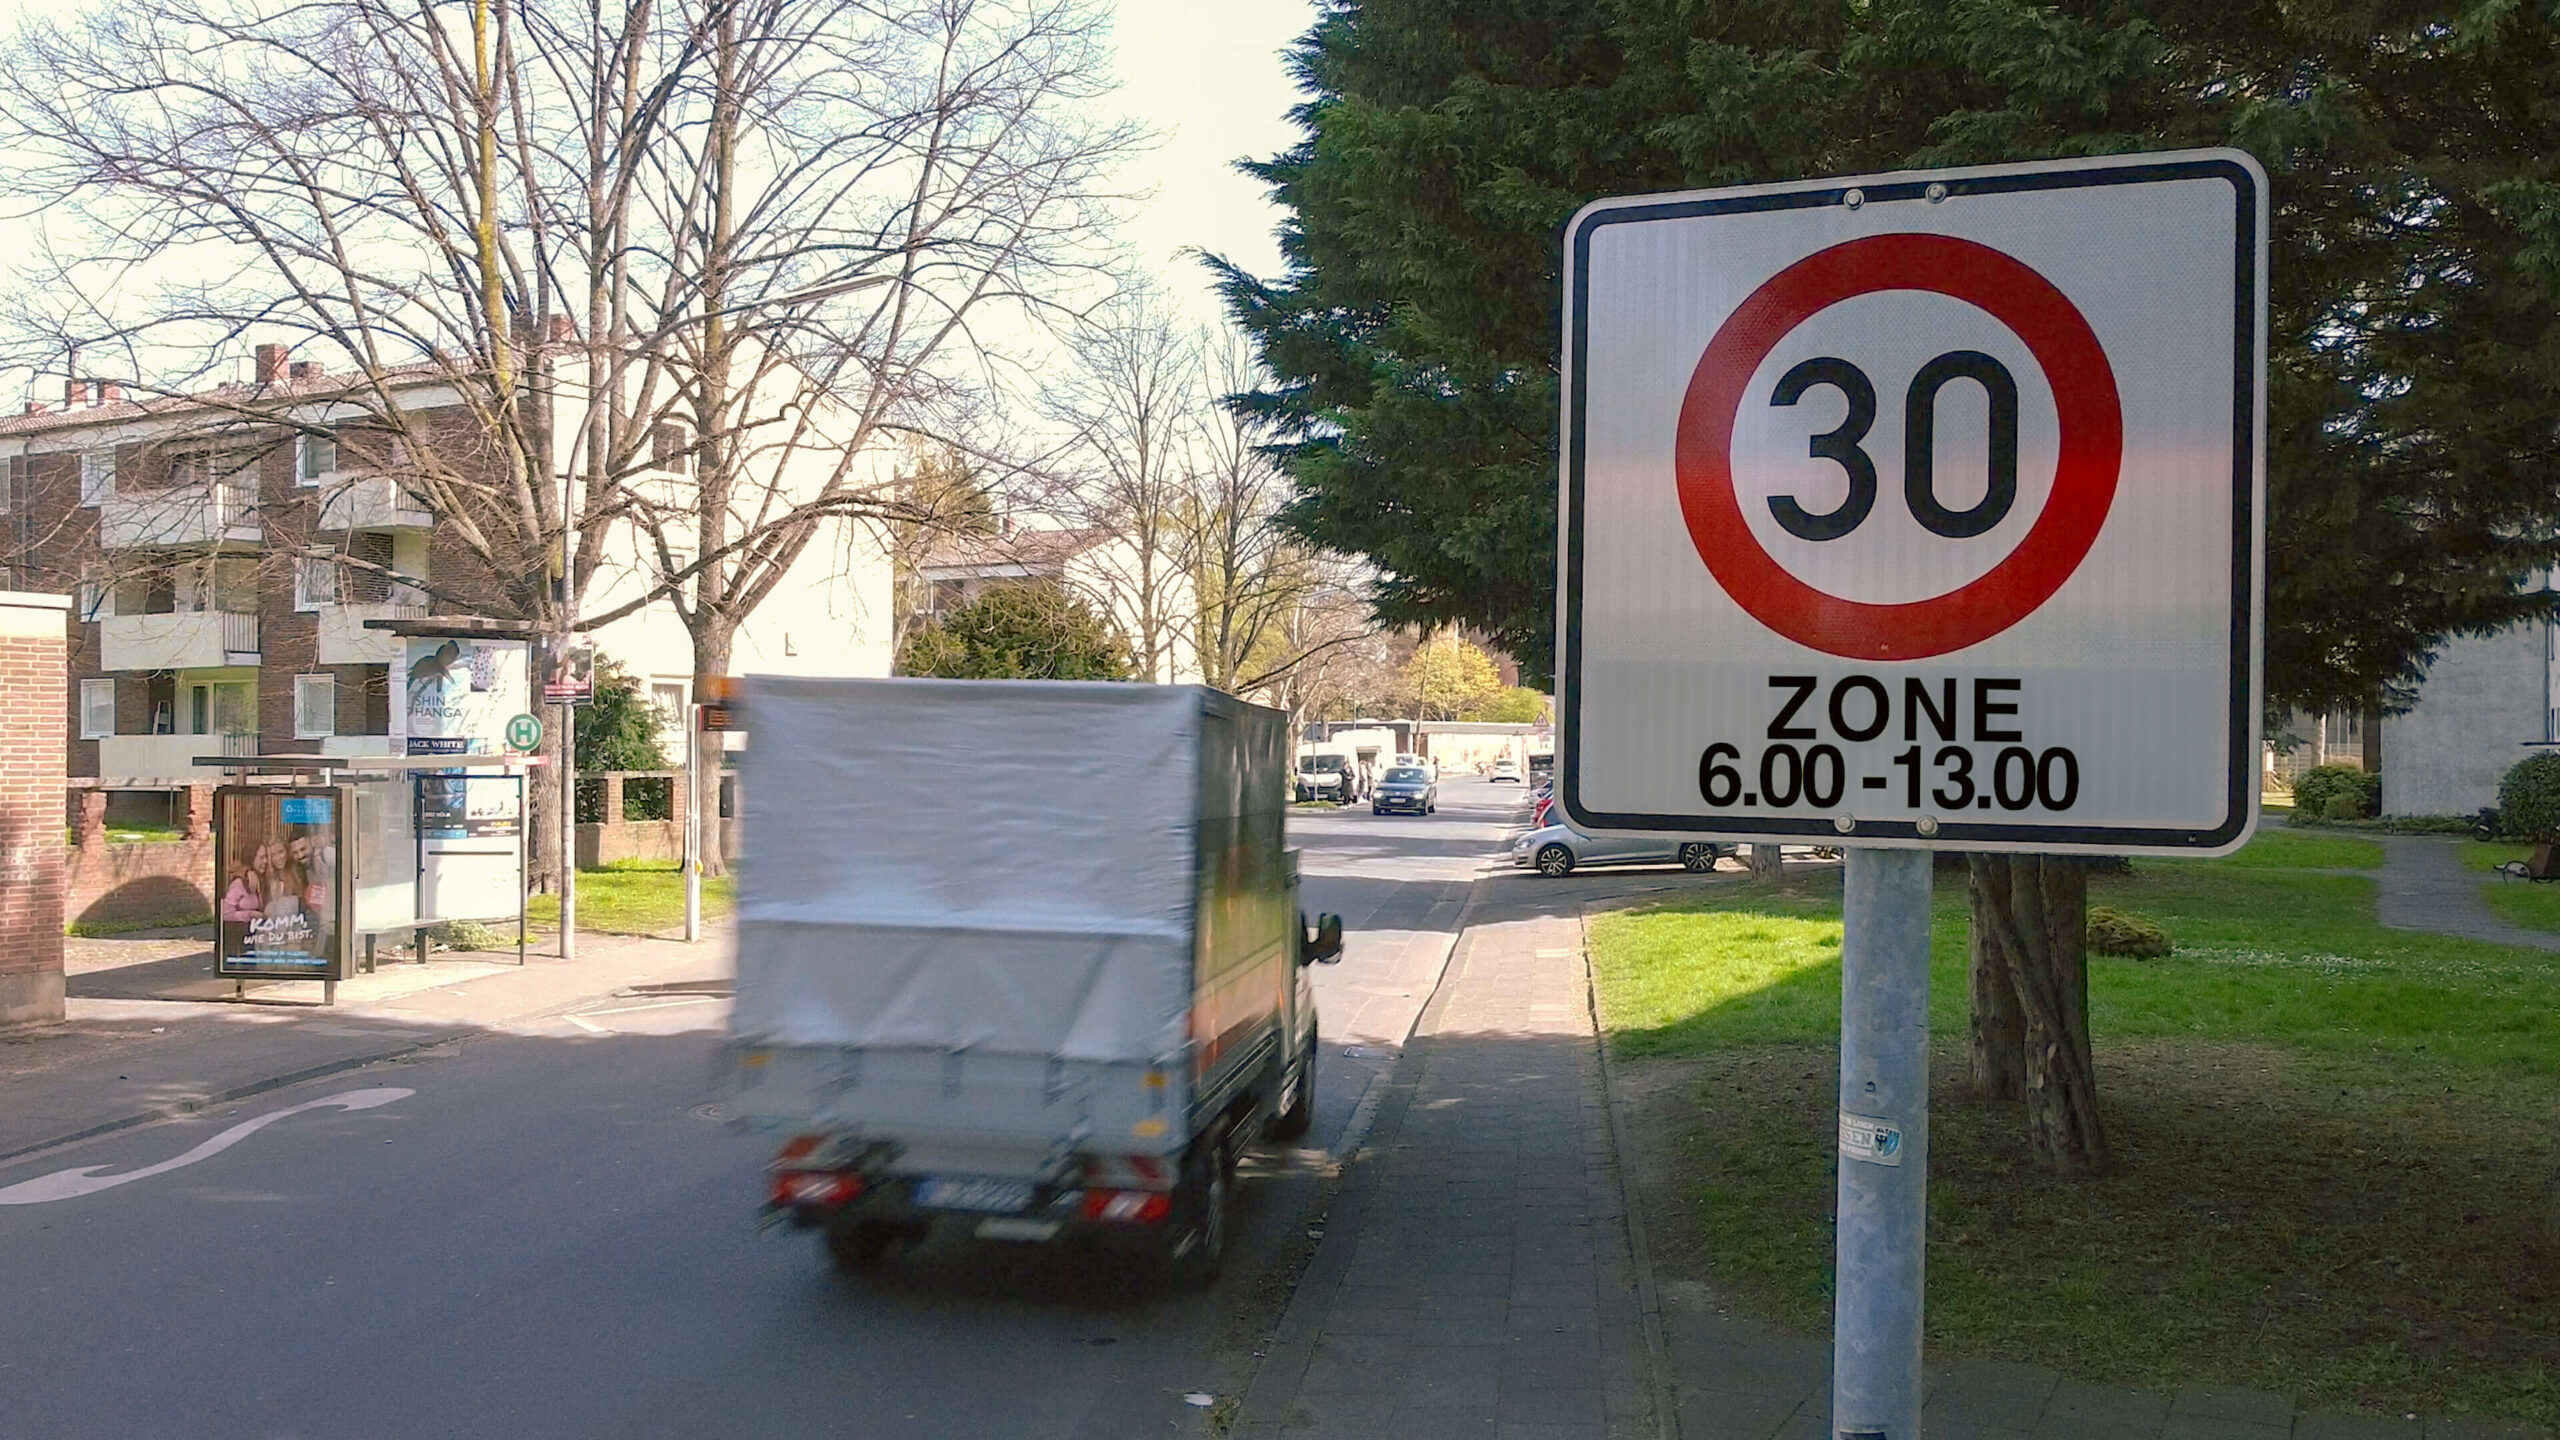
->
(0, 928), (732, 1161)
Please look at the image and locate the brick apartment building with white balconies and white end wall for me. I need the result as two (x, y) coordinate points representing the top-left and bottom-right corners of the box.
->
(0, 346), (893, 784)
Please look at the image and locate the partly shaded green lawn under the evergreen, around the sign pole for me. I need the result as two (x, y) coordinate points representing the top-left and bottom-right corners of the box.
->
(1592, 830), (2560, 1425)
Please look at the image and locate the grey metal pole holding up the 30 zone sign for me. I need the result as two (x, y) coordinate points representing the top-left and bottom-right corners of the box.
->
(1830, 848), (1930, 1440)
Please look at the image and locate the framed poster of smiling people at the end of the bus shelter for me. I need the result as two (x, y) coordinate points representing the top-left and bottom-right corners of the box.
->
(212, 784), (348, 979)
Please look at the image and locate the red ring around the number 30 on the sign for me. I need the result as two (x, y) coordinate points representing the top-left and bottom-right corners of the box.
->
(1672, 236), (2125, 661)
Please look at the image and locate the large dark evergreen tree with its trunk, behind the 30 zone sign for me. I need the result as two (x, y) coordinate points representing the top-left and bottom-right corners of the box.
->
(1219, 0), (2560, 1171)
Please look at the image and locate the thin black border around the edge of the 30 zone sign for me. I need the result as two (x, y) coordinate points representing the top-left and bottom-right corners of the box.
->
(1556, 156), (2260, 853)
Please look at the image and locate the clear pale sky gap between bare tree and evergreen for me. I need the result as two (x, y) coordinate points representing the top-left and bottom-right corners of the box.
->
(1114, 0), (1316, 320)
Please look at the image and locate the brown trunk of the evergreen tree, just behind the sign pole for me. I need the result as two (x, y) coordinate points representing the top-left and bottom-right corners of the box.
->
(1974, 856), (2107, 1176)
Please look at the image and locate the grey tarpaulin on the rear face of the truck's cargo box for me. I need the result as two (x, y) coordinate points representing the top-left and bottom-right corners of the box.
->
(732, 676), (1203, 1061)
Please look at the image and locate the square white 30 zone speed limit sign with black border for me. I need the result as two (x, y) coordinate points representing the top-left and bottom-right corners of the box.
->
(1559, 151), (2266, 853)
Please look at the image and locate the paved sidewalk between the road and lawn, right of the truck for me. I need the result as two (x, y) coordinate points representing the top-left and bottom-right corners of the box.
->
(1236, 901), (1656, 1440)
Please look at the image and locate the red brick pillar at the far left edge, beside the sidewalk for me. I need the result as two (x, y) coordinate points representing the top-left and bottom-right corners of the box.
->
(0, 592), (69, 1025)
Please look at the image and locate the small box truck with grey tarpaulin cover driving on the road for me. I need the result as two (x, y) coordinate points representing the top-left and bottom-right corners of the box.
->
(722, 679), (1341, 1281)
